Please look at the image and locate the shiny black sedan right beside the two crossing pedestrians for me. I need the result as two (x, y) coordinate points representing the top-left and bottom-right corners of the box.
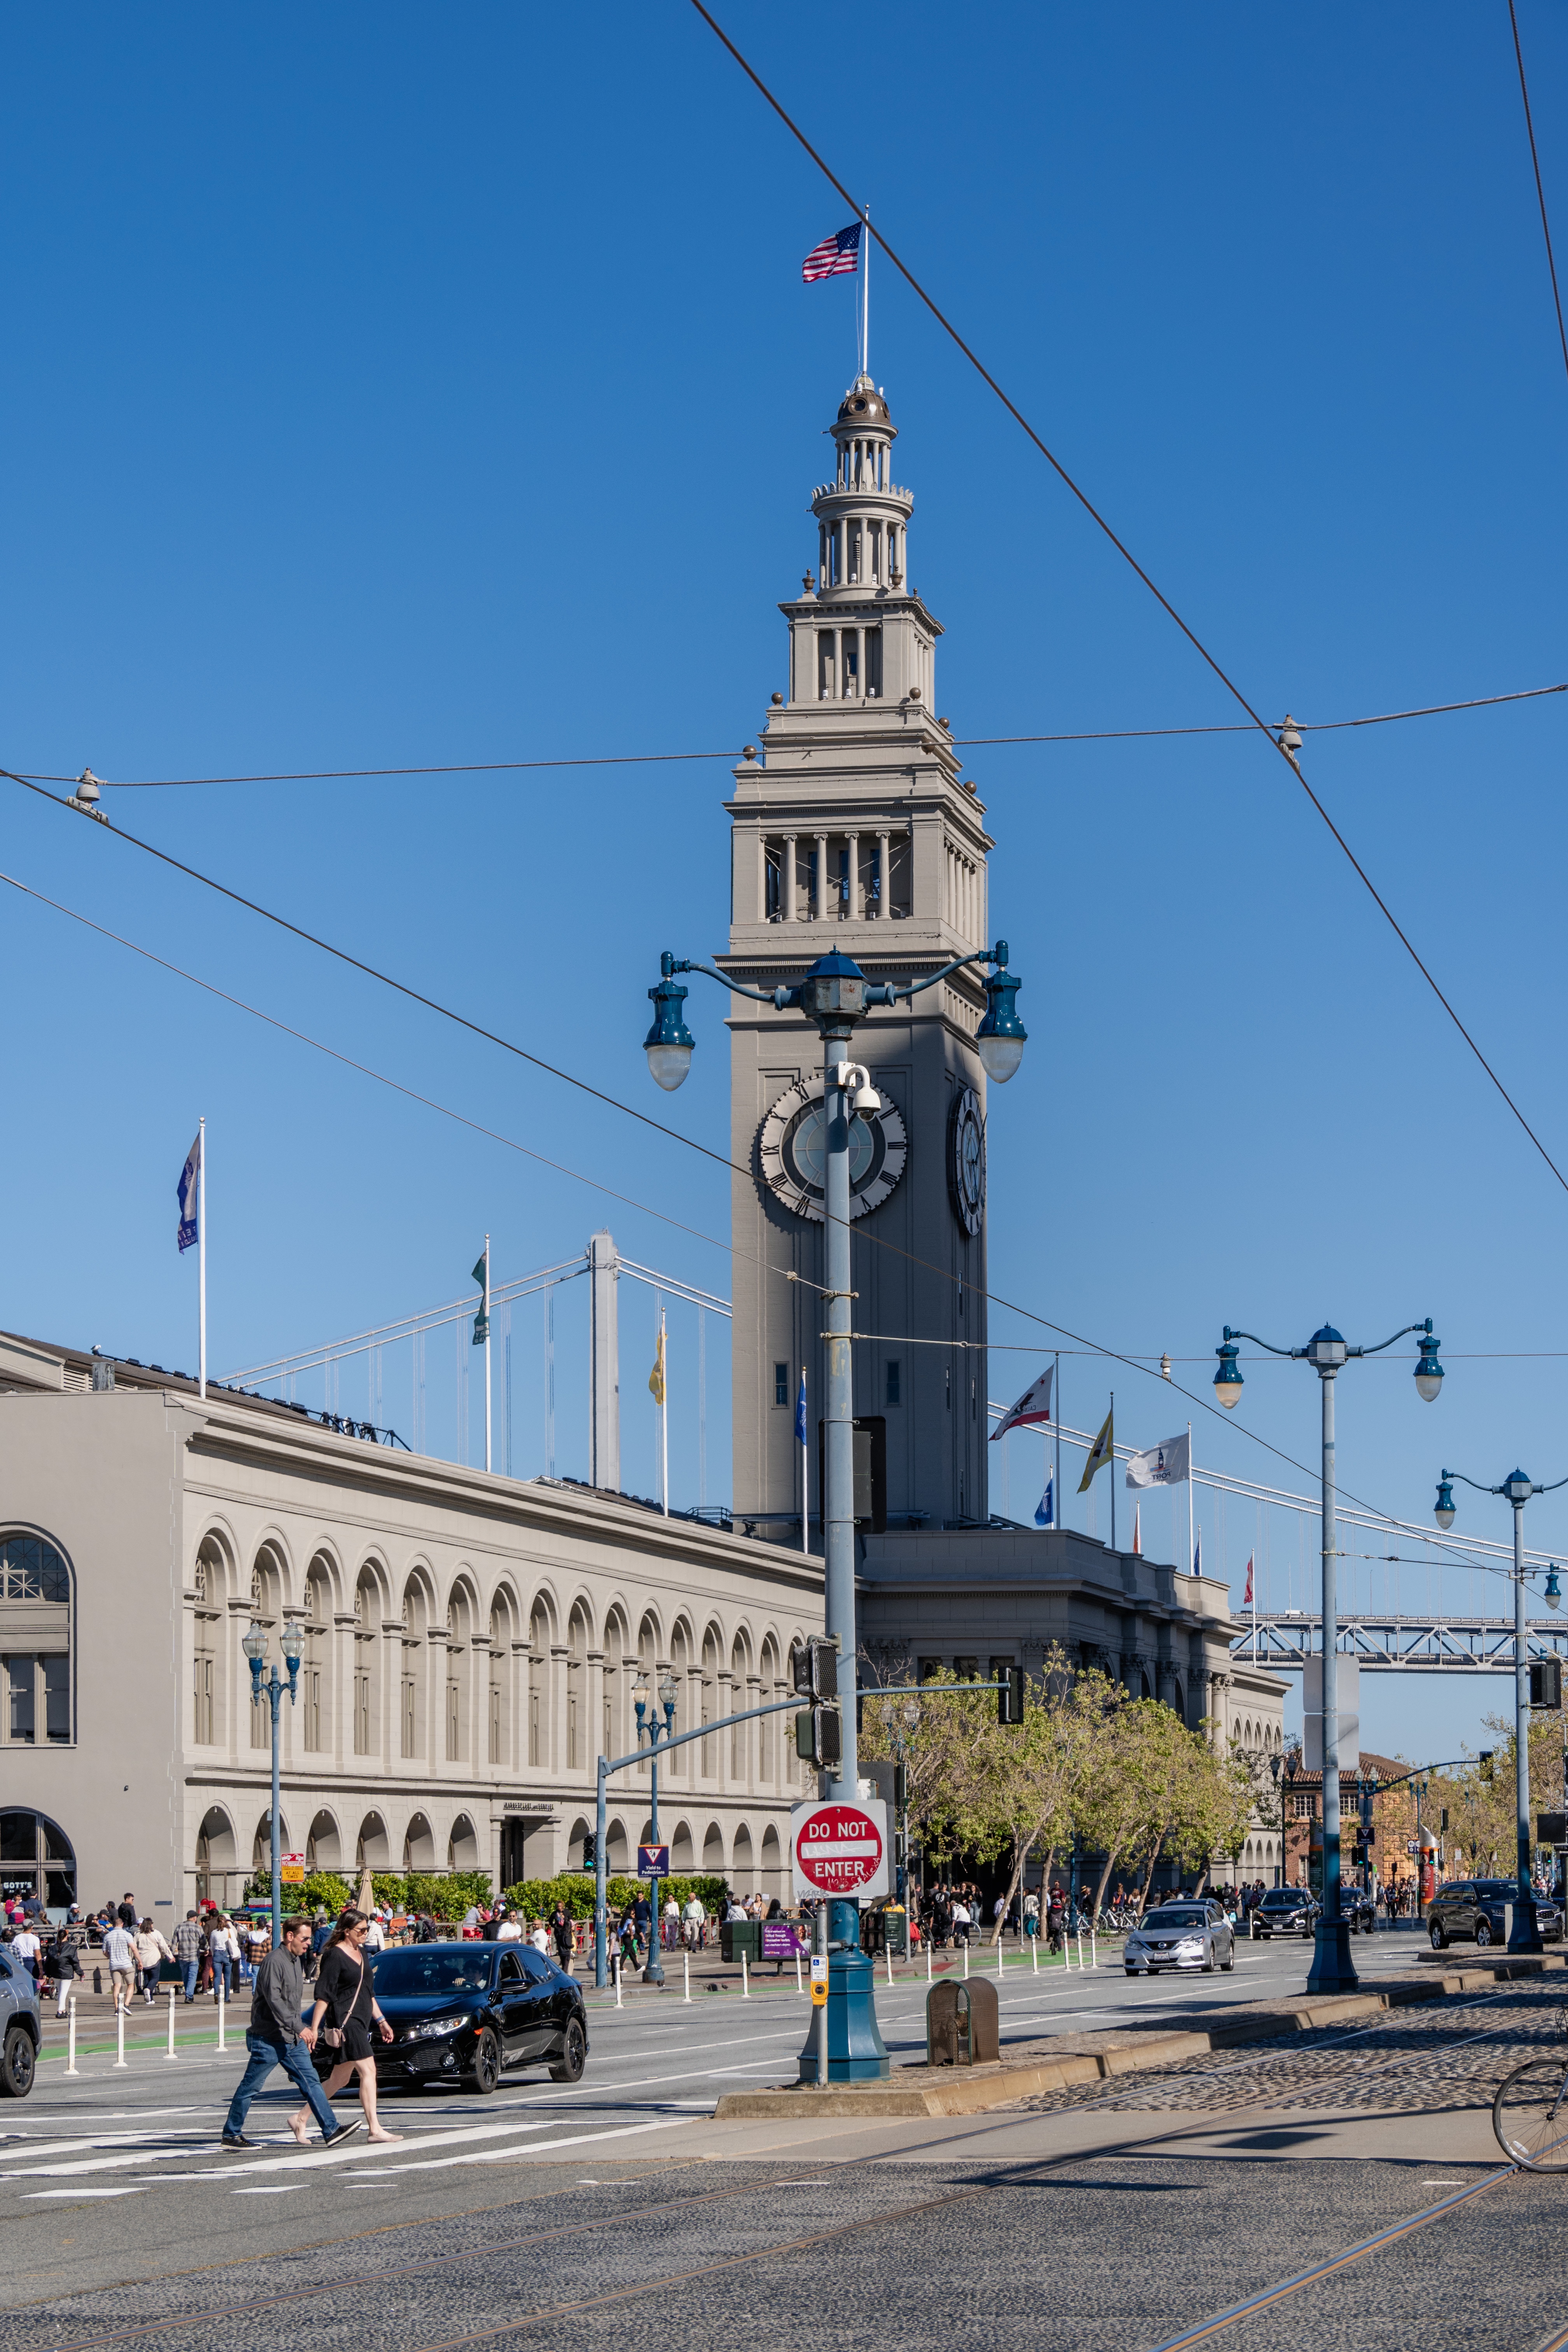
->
(374, 1943), (588, 2093)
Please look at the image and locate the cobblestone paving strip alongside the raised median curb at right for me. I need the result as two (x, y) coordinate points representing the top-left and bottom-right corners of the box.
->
(1001, 1983), (1568, 2114)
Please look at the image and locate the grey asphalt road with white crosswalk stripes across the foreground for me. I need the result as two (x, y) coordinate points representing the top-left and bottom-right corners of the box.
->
(0, 1936), (1568, 2352)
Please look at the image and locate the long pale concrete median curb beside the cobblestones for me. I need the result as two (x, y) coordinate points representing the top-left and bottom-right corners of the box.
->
(712, 1955), (1568, 2124)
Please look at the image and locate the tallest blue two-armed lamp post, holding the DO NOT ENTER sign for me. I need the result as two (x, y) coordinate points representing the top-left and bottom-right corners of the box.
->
(644, 938), (1027, 2081)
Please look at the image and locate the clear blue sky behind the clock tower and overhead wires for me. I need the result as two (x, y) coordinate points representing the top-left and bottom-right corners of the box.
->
(0, 0), (1568, 1752)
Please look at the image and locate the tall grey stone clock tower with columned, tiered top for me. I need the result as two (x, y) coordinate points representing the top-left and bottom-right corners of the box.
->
(722, 376), (992, 1550)
